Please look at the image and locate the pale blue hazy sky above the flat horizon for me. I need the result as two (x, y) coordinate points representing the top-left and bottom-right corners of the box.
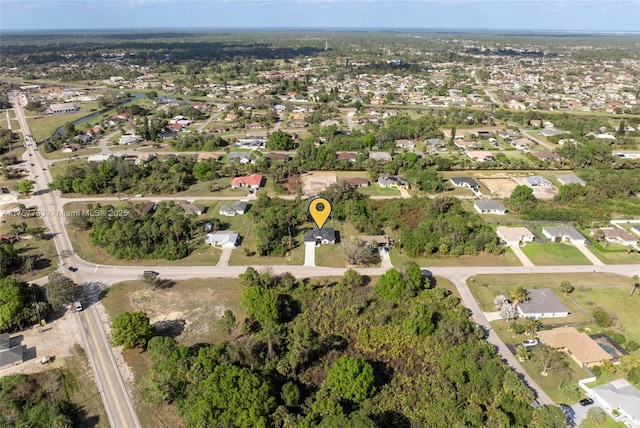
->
(0, 0), (640, 32)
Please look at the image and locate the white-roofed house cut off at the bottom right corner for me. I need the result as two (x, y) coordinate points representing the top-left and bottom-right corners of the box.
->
(591, 378), (640, 427)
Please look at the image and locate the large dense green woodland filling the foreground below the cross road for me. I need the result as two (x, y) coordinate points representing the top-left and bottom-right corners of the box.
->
(139, 265), (544, 427)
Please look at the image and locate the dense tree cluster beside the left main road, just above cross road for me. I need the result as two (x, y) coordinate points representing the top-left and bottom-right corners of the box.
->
(90, 202), (196, 260)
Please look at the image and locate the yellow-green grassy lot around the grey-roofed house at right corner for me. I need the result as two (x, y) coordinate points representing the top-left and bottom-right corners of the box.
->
(468, 273), (640, 343)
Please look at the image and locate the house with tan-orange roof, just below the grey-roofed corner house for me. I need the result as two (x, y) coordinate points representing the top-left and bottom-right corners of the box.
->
(538, 327), (613, 367)
